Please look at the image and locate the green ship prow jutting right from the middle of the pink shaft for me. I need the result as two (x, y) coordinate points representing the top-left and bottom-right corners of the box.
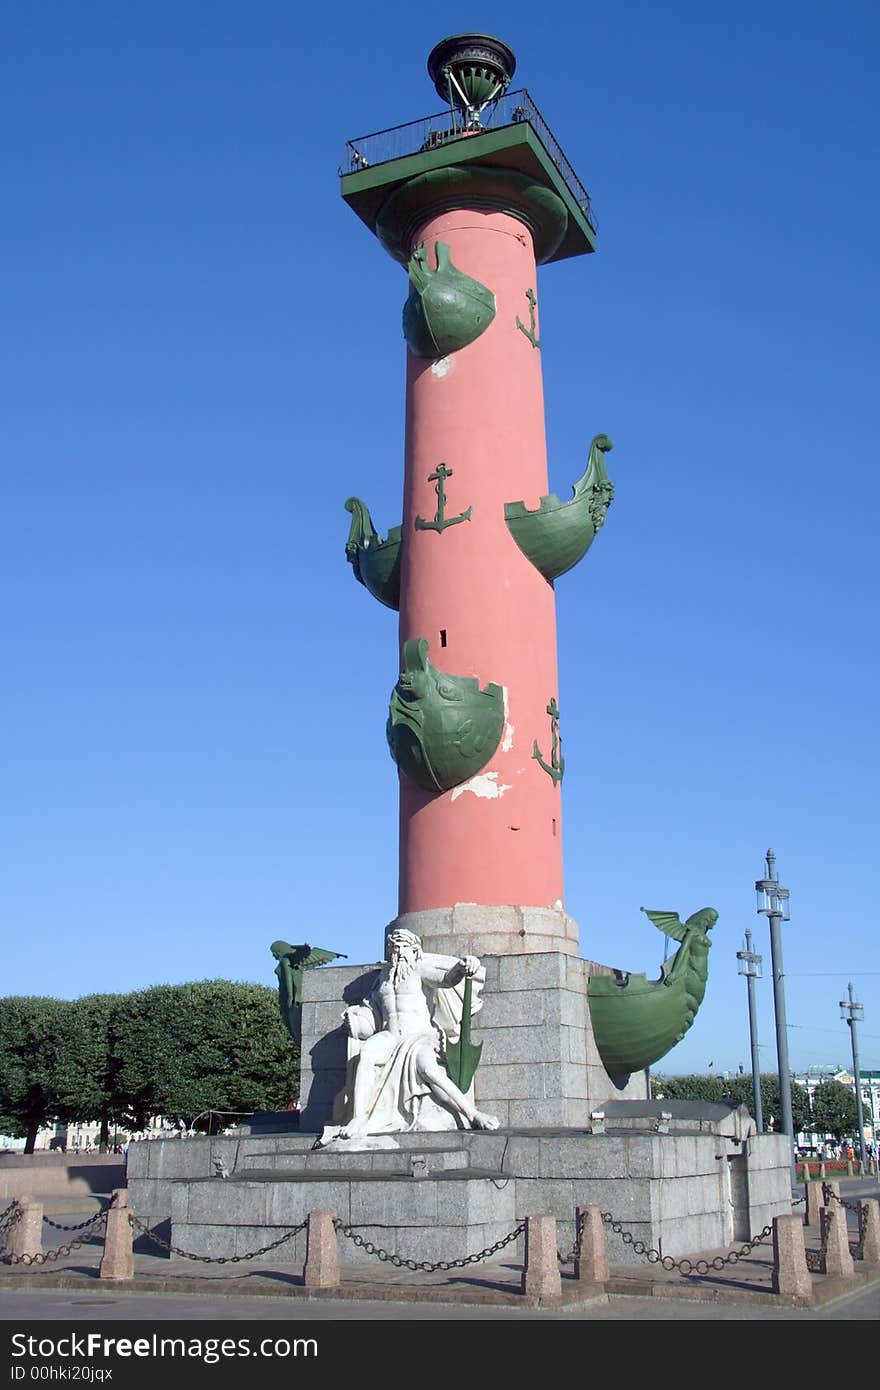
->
(505, 435), (614, 584)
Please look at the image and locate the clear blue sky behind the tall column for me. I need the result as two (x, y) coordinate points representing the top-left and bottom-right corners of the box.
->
(0, 0), (880, 1072)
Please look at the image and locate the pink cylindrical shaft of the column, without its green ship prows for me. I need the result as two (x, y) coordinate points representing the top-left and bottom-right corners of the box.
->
(399, 210), (563, 913)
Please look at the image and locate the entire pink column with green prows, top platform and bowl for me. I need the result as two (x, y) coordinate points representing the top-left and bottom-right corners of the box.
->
(342, 35), (613, 955)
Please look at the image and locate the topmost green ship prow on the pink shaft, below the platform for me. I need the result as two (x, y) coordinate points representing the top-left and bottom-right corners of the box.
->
(403, 242), (495, 357)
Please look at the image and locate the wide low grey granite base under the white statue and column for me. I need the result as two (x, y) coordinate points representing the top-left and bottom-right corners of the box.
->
(128, 1112), (799, 1268)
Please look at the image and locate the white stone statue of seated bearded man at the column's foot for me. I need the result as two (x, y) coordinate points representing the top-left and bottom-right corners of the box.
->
(321, 929), (498, 1144)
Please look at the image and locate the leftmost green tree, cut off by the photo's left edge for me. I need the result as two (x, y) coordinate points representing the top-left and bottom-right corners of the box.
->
(0, 995), (70, 1154)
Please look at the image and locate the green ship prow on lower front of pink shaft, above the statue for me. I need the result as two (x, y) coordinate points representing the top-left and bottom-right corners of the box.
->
(385, 637), (505, 791)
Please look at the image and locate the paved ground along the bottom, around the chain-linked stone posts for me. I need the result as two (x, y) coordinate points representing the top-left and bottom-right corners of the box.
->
(0, 1179), (880, 1322)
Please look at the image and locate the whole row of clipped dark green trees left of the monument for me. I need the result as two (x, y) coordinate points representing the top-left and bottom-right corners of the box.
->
(0, 980), (298, 1152)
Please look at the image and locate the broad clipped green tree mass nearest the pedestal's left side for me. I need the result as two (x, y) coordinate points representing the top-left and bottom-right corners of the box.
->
(111, 980), (295, 1129)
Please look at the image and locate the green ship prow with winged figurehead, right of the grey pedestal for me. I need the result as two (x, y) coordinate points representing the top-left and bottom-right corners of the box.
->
(588, 908), (717, 1083)
